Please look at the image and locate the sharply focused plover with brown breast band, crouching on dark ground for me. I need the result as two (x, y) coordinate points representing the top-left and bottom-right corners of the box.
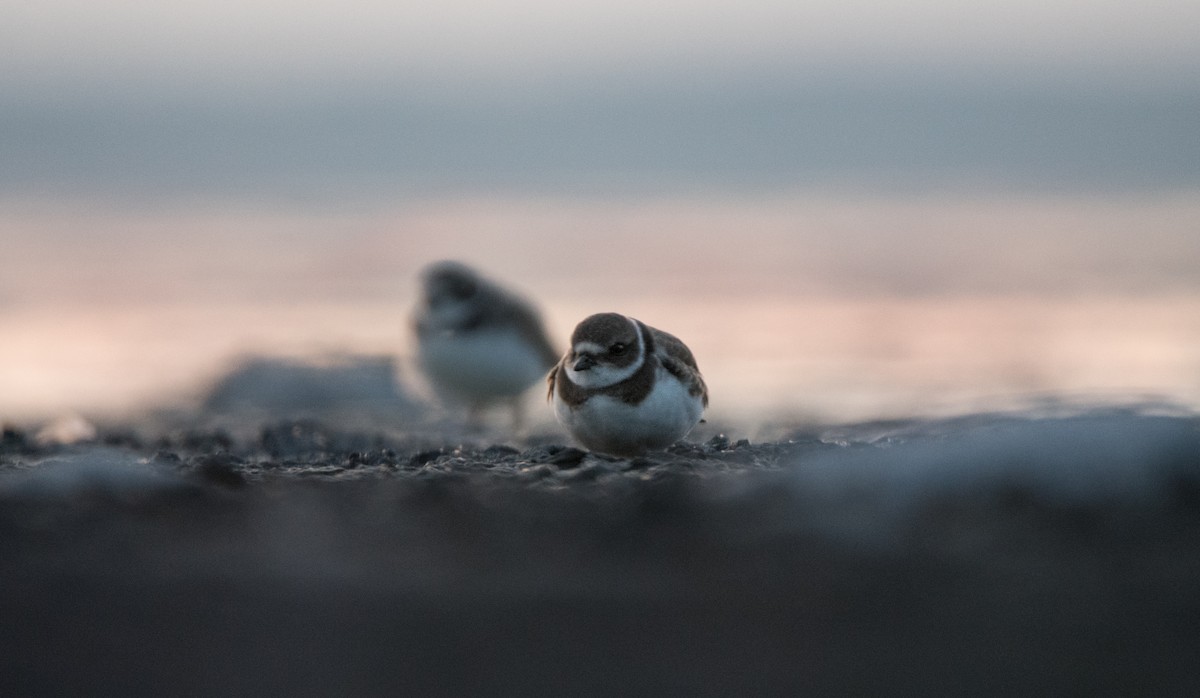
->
(546, 313), (708, 457)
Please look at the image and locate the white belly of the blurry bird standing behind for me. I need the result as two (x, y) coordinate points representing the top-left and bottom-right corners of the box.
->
(416, 330), (548, 404)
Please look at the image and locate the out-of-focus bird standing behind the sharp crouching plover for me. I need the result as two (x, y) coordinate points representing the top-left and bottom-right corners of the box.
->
(413, 260), (558, 431)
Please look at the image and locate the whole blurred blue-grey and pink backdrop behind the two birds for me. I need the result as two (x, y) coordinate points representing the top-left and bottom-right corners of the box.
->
(0, 0), (1200, 421)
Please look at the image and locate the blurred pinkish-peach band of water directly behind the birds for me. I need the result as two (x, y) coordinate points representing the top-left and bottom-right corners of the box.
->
(0, 194), (1200, 420)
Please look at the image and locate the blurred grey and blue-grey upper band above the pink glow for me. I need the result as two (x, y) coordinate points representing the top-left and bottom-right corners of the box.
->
(0, 0), (1200, 199)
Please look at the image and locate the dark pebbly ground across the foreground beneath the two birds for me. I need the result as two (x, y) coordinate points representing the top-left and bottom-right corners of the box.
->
(0, 415), (1200, 696)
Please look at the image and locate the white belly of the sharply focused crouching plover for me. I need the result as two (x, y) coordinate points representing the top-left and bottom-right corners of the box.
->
(554, 368), (704, 456)
